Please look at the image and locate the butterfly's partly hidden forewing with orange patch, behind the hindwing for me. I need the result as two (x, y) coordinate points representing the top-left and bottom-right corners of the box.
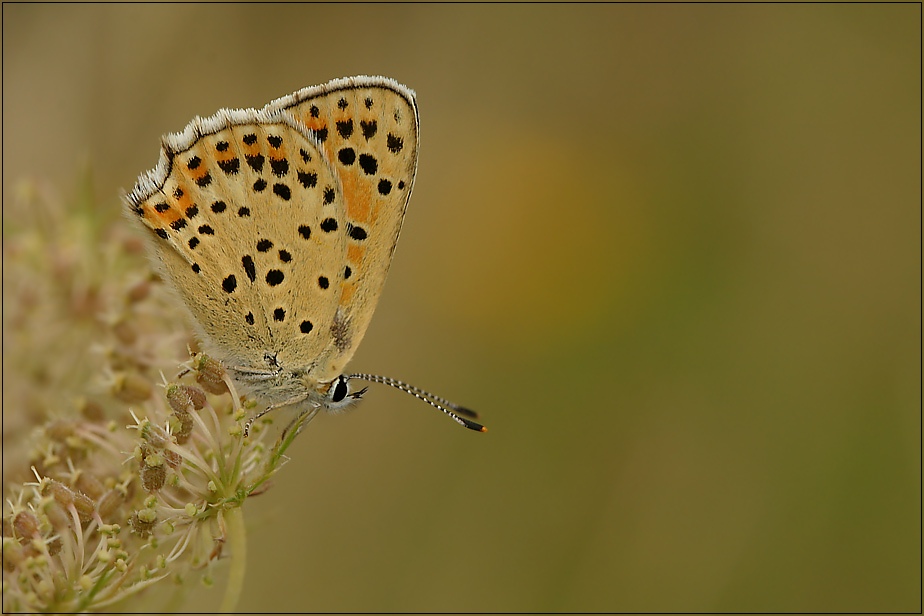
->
(264, 77), (418, 381)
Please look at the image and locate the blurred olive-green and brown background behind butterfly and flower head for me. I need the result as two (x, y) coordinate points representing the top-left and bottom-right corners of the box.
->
(3, 4), (922, 612)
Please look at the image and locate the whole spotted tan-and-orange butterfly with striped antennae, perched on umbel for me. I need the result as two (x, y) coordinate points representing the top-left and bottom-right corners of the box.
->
(125, 76), (486, 432)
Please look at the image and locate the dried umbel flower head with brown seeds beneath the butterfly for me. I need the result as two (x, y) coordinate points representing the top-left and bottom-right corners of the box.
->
(3, 177), (297, 612)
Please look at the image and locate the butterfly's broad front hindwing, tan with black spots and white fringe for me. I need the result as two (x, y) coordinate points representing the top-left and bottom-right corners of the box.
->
(126, 109), (347, 380)
